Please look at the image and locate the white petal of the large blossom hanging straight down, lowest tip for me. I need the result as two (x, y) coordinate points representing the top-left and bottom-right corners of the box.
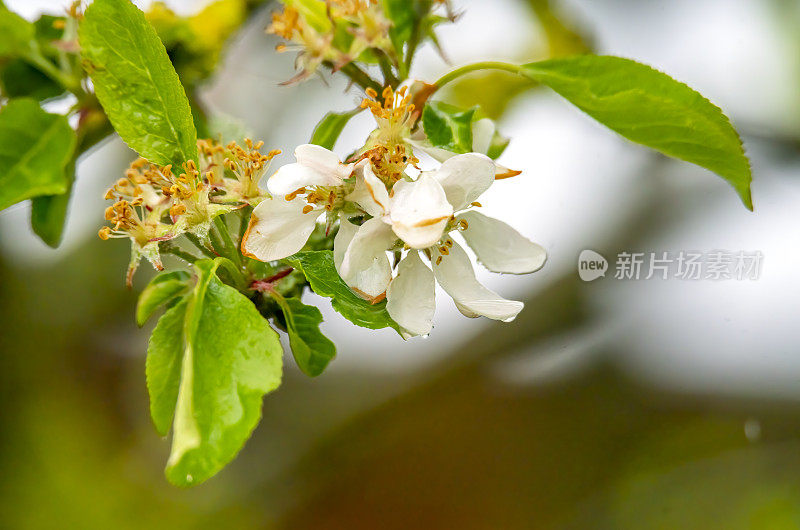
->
(386, 250), (436, 335)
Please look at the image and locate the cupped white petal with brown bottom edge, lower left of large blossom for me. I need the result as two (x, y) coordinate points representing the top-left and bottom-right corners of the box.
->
(334, 214), (395, 296)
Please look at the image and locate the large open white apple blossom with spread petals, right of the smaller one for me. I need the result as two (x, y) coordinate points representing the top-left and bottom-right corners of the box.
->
(336, 153), (546, 335)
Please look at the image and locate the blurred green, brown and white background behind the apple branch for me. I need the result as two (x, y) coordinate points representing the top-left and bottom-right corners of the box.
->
(0, 0), (800, 529)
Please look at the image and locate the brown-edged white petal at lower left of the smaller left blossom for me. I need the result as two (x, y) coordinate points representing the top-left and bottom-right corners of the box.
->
(242, 199), (319, 261)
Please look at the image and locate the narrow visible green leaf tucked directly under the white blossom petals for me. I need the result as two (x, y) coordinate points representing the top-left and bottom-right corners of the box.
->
(286, 250), (400, 332)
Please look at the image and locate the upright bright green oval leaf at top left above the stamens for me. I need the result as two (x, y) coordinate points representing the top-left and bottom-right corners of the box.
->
(79, 0), (197, 167)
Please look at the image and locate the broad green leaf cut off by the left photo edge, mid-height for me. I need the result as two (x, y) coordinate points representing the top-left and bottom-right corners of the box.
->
(0, 99), (75, 210)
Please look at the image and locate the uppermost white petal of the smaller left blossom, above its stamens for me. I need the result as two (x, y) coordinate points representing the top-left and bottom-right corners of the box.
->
(267, 144), (353, 197)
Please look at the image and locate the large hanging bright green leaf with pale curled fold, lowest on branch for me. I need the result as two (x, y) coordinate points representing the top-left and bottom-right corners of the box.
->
(147, 259), (282, 486)
